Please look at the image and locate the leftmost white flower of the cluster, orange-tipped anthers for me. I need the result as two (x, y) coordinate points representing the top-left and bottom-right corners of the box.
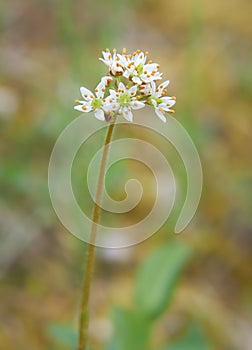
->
(74, 77), (110, 120)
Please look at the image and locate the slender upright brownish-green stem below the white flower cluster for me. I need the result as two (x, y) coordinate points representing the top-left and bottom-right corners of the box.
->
(78, 122), (115, 350)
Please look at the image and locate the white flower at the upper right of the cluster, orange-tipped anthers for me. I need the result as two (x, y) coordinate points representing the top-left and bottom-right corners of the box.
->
(123, 51), (162, 85)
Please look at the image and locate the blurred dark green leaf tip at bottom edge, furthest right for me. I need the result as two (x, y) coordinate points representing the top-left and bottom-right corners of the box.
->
(162, 326), (211, 350)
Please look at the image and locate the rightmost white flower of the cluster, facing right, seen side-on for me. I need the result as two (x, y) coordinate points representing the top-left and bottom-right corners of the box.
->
(150, 80), (176, 122)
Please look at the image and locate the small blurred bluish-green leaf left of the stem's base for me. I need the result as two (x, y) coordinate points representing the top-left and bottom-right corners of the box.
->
(48, 324), (77, 350)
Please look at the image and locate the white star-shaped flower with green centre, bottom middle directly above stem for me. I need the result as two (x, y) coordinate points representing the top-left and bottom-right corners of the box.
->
(106, 82), (145, 122)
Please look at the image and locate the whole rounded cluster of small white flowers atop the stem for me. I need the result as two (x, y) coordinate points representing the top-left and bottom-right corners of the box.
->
(74, 49), (176, 122)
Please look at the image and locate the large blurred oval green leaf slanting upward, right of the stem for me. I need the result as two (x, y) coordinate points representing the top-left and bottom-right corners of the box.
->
(135, 241), (191, 319)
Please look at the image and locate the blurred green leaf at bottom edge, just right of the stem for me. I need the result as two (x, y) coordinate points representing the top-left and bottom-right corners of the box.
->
(106, 308), (150, 350)
